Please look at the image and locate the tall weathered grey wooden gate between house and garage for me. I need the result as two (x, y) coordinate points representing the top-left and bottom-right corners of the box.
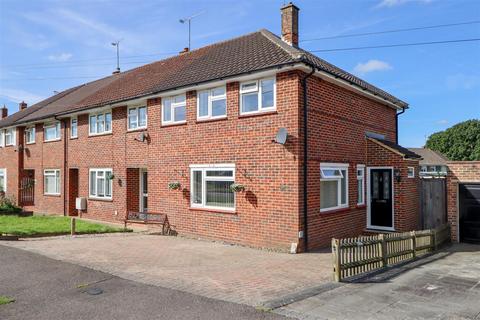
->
(420, 178), (447, 229)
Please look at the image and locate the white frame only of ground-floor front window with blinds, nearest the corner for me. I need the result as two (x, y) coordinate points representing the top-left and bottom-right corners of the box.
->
(190, 163), (237, 212)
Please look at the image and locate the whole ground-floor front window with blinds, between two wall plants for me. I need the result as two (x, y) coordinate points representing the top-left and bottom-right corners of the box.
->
(190, 164), (235, 211)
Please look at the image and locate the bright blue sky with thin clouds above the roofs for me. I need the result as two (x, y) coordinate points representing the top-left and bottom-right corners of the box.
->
(0, 0), (480, 146)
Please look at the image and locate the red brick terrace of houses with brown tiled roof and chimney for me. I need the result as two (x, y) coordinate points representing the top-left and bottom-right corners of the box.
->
(0, 3), (420, 251)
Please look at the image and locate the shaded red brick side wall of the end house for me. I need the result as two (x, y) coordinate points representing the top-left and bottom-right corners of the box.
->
(301, 77), (402, 248)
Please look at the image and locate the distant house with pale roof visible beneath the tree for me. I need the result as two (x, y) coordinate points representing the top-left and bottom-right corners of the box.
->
(408, 148), (448, 178)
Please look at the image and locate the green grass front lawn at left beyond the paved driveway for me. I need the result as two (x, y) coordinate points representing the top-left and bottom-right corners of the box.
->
(0, 215), (130, 236)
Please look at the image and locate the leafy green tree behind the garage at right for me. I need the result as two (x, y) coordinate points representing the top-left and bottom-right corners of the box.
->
(425, 119), (480, 161)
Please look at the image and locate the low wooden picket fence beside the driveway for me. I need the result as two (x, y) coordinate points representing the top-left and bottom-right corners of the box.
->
(332, 225), (450, 281)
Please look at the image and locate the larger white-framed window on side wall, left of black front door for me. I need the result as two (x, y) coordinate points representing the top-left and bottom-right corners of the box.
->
(320, 163), (349, 212)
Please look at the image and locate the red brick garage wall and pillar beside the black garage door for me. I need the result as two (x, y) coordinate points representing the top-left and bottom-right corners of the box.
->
(447, 161), (480, 241)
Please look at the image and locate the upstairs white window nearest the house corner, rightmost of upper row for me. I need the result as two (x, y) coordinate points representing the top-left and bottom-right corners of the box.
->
(240, 78), (276, 114)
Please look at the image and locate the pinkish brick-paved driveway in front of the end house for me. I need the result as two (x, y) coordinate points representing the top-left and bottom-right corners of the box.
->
(1, 234), (331, 306)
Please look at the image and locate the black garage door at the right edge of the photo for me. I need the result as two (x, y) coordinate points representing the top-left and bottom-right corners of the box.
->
(458, 184), (480, 243)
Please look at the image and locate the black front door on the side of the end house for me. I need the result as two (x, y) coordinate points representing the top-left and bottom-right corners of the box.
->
(370, 169), (393, 228)
